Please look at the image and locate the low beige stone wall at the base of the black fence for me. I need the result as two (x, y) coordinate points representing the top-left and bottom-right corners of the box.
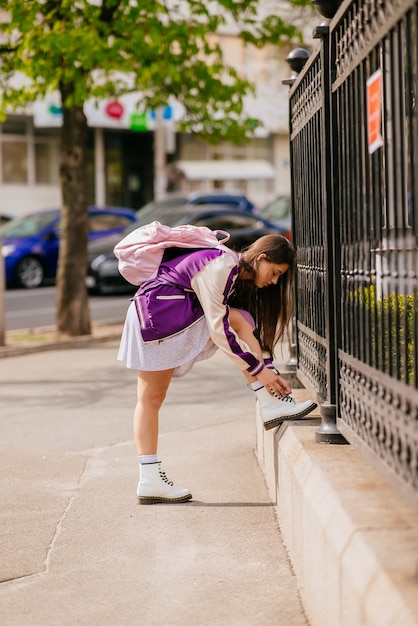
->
(256, 389), (418, 626)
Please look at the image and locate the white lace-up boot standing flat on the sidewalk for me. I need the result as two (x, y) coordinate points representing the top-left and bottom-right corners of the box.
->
(137, 461), (192, 504)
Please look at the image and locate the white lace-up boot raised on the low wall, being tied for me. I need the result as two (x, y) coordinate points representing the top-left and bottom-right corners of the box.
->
(248, 383), (318, 430)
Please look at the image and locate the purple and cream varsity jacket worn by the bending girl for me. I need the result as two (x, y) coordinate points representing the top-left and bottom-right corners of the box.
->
(133, 249), (264, 376)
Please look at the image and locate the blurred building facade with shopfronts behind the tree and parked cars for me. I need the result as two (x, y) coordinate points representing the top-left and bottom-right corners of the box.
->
(0, 6), (309, 216)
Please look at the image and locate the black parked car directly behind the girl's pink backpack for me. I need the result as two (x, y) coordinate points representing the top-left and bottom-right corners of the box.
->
(86, 205), (285, 293)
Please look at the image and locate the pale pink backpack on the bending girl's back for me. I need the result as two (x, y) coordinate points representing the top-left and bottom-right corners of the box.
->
(113, 222), (230, 285)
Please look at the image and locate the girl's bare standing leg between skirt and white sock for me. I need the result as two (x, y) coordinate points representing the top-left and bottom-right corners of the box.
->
(134, 369), (174, 455)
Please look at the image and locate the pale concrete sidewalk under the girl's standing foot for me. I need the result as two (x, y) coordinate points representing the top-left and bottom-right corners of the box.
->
(0, 341), (308, 626)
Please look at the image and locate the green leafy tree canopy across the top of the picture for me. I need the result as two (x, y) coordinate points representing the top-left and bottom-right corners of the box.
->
(0, 0), (304, 141)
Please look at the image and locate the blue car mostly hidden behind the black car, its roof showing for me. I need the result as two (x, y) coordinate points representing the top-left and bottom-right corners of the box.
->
(138, 190), (255, 224)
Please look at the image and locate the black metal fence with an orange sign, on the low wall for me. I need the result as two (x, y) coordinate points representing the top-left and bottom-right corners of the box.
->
(289, 0), (418, 495)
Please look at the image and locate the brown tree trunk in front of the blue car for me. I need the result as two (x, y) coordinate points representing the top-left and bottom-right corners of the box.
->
(56, 92), (91, 337)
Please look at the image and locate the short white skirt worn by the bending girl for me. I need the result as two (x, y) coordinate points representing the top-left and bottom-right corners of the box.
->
(117, 302), (217, 378)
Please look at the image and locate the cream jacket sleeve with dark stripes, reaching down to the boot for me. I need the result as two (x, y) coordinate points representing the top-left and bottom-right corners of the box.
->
(191, 253), (264, 376)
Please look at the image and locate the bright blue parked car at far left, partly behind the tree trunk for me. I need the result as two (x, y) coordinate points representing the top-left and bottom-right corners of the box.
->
(0, 207), (137, 289)
